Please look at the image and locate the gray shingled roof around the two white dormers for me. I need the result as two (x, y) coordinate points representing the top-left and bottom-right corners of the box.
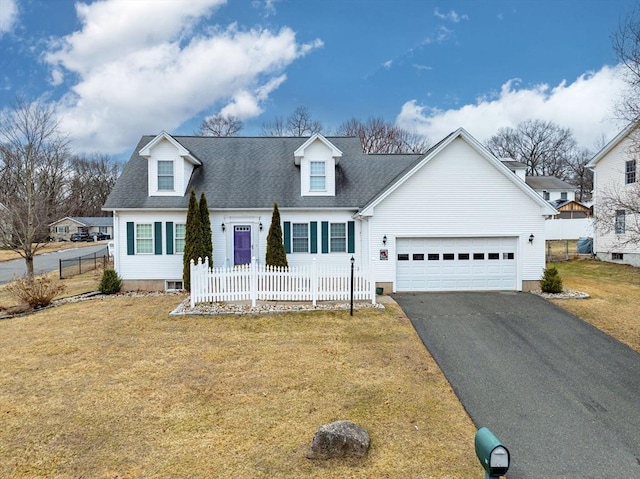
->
(103, 136), (424, 209)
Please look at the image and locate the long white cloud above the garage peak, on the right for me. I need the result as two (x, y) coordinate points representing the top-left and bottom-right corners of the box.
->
(396, 66), (624, 148)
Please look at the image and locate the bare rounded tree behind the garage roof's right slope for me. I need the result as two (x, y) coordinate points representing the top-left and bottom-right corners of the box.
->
(486, 120), (576, 180)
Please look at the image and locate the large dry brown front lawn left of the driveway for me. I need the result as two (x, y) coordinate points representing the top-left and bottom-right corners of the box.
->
(0, 296), (481, 479)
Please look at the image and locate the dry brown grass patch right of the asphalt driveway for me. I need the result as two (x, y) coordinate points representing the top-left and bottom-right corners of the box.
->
(553, 260), (640, 352)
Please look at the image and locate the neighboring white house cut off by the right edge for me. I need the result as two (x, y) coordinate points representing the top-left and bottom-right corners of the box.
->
(587, 124), (640, 266)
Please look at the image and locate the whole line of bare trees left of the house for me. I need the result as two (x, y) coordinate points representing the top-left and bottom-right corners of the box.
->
(0, 99), (120, 276)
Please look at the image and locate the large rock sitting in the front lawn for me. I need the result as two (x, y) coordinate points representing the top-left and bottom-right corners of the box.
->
(307, 421), (371, 459)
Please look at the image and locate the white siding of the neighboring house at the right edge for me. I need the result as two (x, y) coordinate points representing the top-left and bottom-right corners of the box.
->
(594, 133), (640, 266)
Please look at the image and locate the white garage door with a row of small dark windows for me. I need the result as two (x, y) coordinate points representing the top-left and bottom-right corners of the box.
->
(396, 238), (517, 291)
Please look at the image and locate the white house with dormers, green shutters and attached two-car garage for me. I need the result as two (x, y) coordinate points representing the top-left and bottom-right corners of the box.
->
(103, 129), (557, 292)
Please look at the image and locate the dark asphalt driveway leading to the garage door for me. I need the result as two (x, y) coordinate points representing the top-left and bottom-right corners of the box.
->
(393, 292), (640, 479)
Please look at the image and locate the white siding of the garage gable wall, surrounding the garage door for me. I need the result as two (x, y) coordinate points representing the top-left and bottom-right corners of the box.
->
(369, 138), (545, 289)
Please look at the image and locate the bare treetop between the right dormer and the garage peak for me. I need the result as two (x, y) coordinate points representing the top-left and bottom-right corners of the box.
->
(336, 117), (429, 154)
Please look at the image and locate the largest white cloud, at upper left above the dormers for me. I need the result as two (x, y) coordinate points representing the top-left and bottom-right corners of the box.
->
(46, 0), (322, 153)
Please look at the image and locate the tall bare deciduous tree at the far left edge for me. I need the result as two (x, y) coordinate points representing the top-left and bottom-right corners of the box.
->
(0, 100), (68, 277)
